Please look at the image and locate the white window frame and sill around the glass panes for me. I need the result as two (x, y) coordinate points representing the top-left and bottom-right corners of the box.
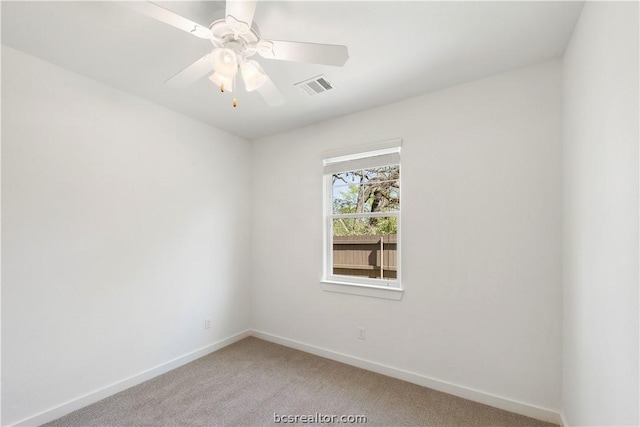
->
(321, 139), (403, 300)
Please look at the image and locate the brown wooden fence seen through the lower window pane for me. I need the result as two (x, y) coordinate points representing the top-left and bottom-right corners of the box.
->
(333, 234), (398, 279)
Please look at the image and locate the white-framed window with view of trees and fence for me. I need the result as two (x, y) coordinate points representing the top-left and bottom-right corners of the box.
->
(324, 141), (400, 293)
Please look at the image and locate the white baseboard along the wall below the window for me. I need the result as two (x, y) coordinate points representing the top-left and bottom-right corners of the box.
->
(251, 329), (563, 424)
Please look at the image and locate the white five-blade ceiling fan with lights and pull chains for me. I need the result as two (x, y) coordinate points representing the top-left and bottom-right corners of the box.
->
(122, 0), (349, 107)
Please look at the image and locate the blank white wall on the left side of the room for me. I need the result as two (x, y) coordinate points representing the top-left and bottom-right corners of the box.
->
(2, 46), (250, 425)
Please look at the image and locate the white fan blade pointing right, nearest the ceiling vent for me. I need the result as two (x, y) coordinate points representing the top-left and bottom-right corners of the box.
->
(258, 40), (349, 66)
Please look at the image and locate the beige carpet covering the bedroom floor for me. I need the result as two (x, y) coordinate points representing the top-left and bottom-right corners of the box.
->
(46, 338), (553, 427)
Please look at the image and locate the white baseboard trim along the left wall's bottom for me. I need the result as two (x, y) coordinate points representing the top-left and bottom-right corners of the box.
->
(13, 329), (251, 426)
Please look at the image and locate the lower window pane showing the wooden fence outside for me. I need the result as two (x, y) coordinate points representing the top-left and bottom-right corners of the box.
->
(333, 217), (398, 280)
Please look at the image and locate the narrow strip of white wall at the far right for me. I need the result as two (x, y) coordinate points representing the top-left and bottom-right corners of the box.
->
(563, 2), (640, 426)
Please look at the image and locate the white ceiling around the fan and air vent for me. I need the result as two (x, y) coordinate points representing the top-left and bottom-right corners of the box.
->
(2, 1), (583, 140)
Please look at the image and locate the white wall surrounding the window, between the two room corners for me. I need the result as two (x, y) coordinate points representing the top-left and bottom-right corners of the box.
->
(252, 60), (562, 413)
